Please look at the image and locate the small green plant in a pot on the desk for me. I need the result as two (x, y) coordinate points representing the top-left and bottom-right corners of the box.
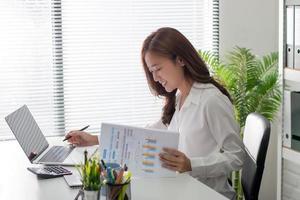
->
(78, 151), (103, 200)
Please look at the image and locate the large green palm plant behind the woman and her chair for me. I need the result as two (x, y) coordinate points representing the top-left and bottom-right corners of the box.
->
(199, 47), (282, 199)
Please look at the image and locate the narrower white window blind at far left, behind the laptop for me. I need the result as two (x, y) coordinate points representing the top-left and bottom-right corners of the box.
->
(0, 0), (55, 139)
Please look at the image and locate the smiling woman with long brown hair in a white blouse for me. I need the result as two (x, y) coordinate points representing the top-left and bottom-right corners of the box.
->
(69, 28), (245, 199)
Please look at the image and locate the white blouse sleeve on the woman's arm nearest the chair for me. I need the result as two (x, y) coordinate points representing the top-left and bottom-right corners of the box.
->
(190, 95), (245, 178)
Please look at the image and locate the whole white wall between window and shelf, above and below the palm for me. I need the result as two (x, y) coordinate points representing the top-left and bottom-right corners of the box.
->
(220, 0), (279, 200)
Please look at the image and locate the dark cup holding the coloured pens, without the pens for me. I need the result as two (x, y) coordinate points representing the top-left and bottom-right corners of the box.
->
(105, 181), (131, 200)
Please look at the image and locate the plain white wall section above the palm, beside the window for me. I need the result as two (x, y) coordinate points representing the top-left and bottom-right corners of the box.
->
(220, 0), (278, 55)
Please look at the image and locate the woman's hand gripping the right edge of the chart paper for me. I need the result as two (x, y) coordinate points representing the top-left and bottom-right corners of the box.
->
(159, 148), (192, 173)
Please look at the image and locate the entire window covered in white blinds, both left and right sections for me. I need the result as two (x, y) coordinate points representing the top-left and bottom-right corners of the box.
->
(0, 0), (218, 140)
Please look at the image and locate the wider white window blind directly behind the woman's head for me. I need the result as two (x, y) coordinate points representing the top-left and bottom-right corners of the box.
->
(56, 0), (213, 133)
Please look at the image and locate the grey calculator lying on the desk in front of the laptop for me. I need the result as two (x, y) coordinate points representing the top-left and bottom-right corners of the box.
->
(27, 165), (72, 179)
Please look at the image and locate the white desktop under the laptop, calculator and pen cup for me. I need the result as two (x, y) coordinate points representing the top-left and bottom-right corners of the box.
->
(0, 138), (226, 200)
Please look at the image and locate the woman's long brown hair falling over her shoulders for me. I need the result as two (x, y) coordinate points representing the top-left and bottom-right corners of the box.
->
(141, 27), (231, 125)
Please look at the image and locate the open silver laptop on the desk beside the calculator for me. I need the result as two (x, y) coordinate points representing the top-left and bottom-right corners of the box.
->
(5, 105), (97, 166)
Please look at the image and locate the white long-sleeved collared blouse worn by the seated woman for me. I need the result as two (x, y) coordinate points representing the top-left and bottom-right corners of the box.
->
(150, 83), (245, 199)
